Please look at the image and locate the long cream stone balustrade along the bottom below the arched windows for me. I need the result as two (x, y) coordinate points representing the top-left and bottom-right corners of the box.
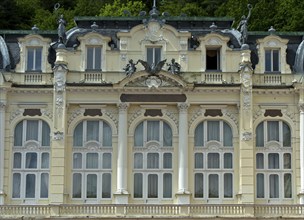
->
(0, 204), (304, 219)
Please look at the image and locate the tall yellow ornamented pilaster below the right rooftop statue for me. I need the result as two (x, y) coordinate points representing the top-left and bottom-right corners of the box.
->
(237, 49), (255, 204)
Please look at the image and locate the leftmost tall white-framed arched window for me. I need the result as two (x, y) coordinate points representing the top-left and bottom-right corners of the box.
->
(12, 120), (50, 200)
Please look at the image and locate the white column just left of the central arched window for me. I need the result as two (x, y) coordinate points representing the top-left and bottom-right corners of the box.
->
(115, 102), (129, 204)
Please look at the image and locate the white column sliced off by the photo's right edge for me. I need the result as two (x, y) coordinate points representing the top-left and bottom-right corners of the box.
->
(299, 103), (304, 204)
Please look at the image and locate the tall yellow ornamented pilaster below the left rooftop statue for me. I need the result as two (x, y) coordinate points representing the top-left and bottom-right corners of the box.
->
(50, 49), (68, 204)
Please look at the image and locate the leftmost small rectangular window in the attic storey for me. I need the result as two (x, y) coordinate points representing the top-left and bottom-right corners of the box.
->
(26, 47), (42, 71)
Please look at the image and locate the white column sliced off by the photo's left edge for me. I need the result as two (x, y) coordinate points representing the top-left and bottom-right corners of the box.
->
(0, 101), (5, 205)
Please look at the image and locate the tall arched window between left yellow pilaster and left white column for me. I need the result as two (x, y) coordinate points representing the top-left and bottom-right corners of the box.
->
(72, 120), (112, 201)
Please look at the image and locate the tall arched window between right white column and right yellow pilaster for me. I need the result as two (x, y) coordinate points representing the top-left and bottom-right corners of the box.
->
(194, 120), (234, 199)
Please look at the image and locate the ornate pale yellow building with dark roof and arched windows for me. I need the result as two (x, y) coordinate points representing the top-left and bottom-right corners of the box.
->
(0, 4), (304, 219)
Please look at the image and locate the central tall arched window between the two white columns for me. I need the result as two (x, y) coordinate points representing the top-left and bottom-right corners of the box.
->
(133, 120), (173, 201)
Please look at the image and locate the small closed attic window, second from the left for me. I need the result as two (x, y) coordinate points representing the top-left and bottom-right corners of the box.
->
(86, 46), (102, 70)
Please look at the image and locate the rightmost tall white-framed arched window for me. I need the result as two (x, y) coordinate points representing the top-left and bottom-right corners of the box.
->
(256, 120), (292, 200)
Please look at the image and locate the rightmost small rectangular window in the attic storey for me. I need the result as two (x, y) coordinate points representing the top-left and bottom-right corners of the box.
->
(265, 49), (280, 72)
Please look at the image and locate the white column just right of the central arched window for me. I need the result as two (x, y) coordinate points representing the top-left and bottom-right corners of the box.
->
(177, 103), (190, 204)
